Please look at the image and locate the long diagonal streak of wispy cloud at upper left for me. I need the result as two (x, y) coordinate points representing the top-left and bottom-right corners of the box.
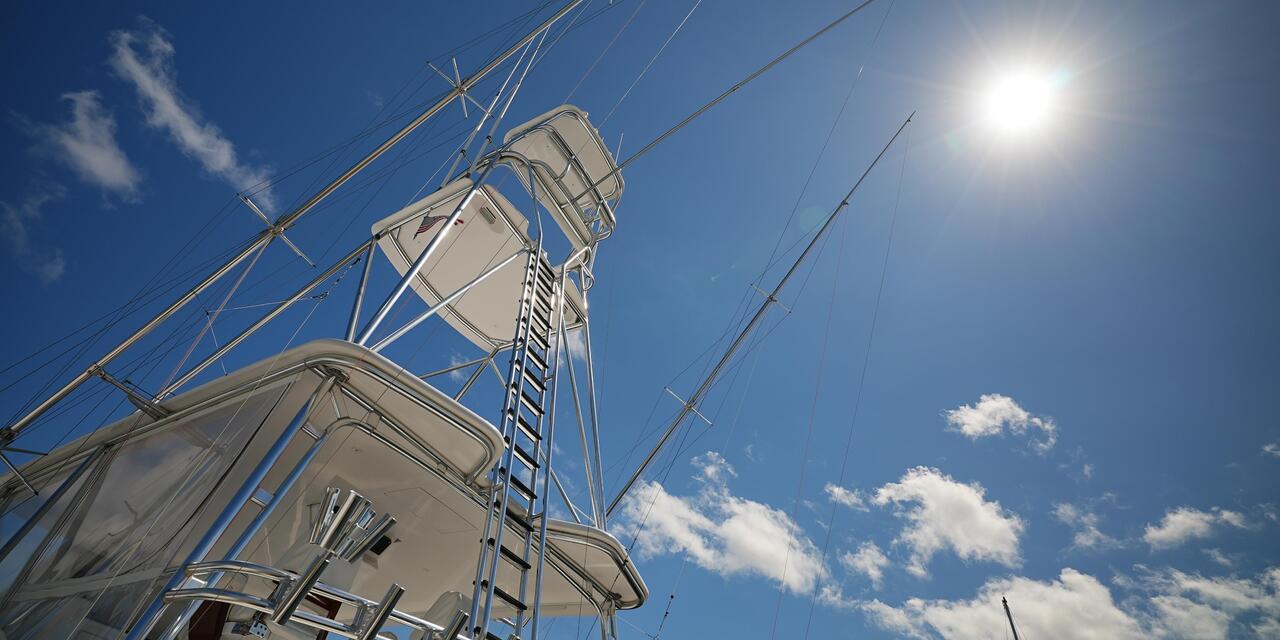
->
(110, 19), (275, 210)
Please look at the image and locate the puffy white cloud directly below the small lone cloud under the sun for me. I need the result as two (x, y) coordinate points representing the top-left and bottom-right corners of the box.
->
(873, 467), (1027, 577)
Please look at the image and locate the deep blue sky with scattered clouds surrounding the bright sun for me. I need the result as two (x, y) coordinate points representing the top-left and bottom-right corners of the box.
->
(0, 0), (1280, 637)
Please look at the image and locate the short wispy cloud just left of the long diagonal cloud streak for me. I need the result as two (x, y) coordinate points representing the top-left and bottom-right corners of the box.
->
(31, 91), (142, 202)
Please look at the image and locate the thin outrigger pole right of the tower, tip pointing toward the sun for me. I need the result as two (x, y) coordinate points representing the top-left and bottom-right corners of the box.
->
(604, 111), (915, 516)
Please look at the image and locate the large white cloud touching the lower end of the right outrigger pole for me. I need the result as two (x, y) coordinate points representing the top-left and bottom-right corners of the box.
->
(620, 452), (828, 594)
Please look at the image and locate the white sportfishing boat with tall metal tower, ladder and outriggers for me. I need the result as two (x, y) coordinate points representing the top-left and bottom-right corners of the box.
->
(0, 0), (905, 640)
